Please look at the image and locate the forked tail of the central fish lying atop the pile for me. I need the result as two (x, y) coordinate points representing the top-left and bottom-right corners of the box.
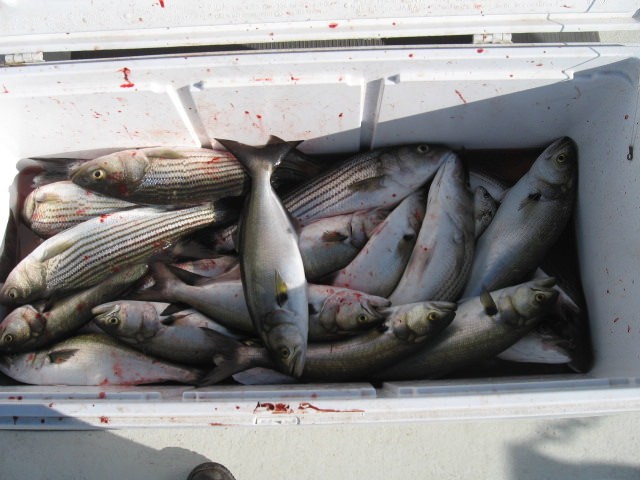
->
(216, 137), (300, 177)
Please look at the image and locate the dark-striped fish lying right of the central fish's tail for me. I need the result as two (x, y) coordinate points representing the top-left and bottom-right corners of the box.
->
(282, 144), (453, 225)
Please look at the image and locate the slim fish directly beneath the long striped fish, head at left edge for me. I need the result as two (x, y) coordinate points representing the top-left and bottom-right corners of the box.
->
(0, 264), (147, 352)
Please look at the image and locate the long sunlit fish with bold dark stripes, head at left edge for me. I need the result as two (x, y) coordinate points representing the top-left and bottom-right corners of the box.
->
(0, 204), (225, 303)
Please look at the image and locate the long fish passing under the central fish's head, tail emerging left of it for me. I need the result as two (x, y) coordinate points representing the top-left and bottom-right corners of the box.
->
(202, 302), (456, 385)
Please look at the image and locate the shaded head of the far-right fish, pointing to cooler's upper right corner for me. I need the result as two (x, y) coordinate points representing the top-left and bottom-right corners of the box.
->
(531, 137), (578, 187)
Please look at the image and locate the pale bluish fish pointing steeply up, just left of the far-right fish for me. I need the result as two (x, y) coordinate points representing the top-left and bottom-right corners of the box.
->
(389, 156), (475, 305)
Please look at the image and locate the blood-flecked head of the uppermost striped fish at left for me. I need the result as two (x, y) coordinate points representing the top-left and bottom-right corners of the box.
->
(71, 150), (149, 197)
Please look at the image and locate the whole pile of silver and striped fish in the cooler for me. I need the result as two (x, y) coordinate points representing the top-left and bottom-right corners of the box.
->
(0, 137), (591, 385)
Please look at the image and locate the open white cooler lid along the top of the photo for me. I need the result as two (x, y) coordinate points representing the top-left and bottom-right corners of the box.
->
(0, 0), (640, 55)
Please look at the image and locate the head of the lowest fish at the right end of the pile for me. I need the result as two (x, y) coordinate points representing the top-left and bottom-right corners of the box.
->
(507, 277), (558, 327)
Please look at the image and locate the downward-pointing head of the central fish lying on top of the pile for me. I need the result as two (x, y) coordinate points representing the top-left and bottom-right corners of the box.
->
(263, 309), (307, 378)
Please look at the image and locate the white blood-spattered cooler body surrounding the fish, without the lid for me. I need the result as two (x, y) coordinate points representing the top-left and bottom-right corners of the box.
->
(0, 45), (640, 429)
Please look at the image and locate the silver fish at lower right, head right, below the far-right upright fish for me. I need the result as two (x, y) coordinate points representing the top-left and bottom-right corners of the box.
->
(375, 279), (558, 380)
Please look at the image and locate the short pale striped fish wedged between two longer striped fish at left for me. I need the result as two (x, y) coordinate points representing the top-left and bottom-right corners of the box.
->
(22, 180), (137, 238)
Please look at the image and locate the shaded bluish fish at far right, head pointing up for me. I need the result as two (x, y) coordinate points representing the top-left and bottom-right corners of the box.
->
(463, 137), (577, 297)
